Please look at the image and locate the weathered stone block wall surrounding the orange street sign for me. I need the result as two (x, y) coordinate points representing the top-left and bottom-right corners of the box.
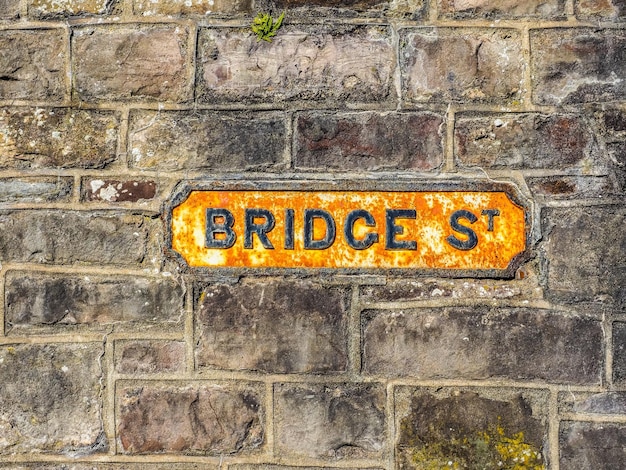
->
(0, 0), (626, 470)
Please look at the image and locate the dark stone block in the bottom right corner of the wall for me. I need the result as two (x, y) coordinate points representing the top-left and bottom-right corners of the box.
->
(559, 421), (626, 470)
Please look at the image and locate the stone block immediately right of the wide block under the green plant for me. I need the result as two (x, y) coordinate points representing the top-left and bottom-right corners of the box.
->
(400, 28), (523, 103)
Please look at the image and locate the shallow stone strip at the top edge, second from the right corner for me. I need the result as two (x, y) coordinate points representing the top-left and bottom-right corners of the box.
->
(437, 0), (565, 18)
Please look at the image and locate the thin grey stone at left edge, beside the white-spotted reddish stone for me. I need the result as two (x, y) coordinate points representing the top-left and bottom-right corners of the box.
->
(0, 176), (73, 202)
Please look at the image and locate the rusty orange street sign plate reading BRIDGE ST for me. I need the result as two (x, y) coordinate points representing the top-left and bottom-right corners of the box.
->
(169, 180), (528, 271)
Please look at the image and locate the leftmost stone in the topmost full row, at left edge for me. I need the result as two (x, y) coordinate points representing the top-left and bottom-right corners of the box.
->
(0, 29), (67, 101)
